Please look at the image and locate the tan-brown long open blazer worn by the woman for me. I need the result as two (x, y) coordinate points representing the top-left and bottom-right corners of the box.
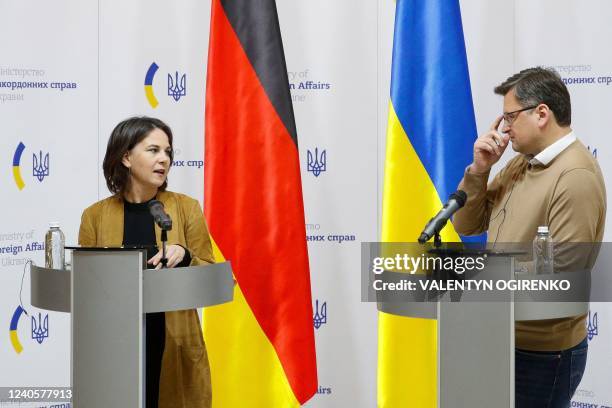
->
(79, 191), (214, 408)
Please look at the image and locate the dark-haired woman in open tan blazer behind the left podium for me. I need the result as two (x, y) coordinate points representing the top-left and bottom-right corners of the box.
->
(79, 117), (214, 408)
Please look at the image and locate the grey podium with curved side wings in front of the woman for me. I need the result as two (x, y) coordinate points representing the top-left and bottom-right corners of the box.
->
(30, 248), (234, 408)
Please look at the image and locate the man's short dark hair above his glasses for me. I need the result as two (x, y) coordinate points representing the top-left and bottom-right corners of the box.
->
(494, 67), (572, 126)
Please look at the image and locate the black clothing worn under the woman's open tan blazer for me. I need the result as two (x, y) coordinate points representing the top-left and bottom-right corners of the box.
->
(123, 201), (191, 408)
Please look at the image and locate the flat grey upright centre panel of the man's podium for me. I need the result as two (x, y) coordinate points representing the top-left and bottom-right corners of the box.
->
(438, 257), (514, 408)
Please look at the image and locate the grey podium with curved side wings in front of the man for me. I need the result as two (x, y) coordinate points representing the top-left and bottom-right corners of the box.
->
(377, 254), (589, 408)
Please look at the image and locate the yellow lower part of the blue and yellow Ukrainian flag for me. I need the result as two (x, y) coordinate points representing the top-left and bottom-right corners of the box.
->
(378, 103), (460, 408)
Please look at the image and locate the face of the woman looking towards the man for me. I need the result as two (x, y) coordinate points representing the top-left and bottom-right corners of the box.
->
(122, 129), (172, 194)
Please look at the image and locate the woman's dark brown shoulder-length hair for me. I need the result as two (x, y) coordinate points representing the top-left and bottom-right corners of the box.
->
(102, 116), (174, 194)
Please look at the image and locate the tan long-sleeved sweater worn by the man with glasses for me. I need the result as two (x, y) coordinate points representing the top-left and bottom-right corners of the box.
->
(453, 141), (606, 351)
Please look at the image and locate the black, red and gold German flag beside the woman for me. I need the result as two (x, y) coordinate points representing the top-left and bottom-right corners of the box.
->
(204, 0), (317, 407)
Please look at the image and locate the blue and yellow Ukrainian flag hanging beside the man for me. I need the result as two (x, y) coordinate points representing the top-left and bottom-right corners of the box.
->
(378, 0), (476, 408)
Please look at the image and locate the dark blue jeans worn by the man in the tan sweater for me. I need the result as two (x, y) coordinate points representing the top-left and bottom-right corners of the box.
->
(515, 338), (588, 408)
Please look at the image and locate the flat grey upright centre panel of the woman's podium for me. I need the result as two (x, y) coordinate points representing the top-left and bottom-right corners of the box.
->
(71, 251), (145, 408)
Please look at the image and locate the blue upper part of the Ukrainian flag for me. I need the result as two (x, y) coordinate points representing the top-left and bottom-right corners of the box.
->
(391, 0), (476, 202)
